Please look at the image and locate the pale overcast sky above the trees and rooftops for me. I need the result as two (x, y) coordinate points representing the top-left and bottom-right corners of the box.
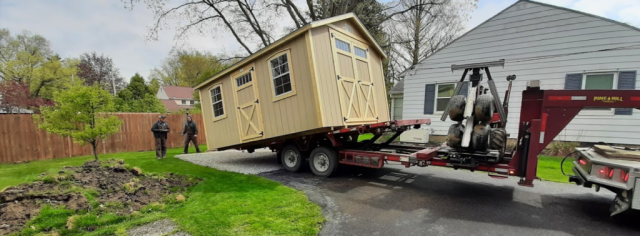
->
(0, 0), (640, 80)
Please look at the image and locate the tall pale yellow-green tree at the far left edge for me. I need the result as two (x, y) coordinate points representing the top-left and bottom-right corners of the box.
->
(0, 29), (78, 99)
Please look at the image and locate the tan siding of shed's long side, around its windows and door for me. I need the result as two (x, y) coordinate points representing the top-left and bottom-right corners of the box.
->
(202, 34), (320, 148)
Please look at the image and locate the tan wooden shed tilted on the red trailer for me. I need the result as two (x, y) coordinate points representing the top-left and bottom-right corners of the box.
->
(195, 13), (389, 149)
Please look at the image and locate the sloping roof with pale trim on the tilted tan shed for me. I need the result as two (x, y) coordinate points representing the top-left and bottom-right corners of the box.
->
(194, 13), (387, 89)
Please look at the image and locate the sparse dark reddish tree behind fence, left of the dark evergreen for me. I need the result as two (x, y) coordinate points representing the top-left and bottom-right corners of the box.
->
(78, 52), (127, 94)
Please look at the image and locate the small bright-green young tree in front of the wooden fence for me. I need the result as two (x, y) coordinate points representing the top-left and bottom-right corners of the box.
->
(34, 85), (123, 160)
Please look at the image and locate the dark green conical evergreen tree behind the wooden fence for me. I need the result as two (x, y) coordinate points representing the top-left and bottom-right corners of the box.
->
(115, 73), (166, 113)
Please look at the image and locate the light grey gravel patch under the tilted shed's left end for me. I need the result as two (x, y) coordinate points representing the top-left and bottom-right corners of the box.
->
(176, 149), (282, 175)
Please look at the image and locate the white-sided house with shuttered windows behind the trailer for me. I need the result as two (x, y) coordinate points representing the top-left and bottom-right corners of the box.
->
(402, 0), (640, 144)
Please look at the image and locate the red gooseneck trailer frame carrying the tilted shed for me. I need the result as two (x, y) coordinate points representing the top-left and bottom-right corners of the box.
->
(284, 87), (640, 187)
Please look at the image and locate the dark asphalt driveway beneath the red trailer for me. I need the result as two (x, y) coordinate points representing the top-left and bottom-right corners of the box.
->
(179, 152), (640, 236)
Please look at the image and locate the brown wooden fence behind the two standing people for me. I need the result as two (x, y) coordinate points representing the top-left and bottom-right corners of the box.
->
(0, 113), (206, 163)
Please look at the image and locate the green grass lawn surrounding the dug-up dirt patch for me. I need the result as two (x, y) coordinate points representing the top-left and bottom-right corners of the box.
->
(0, 148), (324, 235)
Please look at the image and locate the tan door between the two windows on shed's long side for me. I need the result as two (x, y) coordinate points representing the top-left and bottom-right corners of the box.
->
(231, 67), (264, 141)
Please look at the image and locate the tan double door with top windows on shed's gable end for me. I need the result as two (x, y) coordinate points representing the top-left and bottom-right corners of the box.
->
(330, 29), (383, 125)
